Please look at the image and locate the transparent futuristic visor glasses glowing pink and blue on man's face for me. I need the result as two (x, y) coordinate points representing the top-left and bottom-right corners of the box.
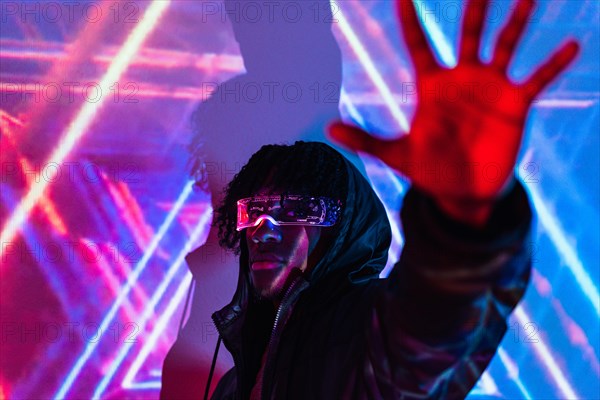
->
(237, 195), (341, 231)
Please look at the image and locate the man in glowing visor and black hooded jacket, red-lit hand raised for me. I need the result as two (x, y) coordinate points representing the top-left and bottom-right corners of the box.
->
(163, 0), (578, 399)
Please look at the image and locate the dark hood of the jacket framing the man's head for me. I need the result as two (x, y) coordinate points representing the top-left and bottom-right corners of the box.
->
(214, 148), (392, 325)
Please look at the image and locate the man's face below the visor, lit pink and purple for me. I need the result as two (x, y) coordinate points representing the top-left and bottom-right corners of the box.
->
(246, 206), (321, 301)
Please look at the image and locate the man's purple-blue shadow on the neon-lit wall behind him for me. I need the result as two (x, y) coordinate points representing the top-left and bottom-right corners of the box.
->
(161, 0), (356, 399)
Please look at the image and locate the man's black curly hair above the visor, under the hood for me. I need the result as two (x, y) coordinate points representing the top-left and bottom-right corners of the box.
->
(213, 141), (348, 254)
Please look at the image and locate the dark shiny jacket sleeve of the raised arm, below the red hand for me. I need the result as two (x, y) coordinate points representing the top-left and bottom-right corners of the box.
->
(368, 182), (532, 399)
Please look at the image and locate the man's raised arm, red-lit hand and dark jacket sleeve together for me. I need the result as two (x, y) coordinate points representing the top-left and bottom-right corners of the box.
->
(330, 0), (579, 399)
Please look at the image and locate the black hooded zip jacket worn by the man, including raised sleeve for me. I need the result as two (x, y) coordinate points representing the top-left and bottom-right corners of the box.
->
(207, 157), (531, 400)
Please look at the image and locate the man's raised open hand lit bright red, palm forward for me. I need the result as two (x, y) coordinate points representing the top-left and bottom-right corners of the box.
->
(330, 0), (579, 225)
